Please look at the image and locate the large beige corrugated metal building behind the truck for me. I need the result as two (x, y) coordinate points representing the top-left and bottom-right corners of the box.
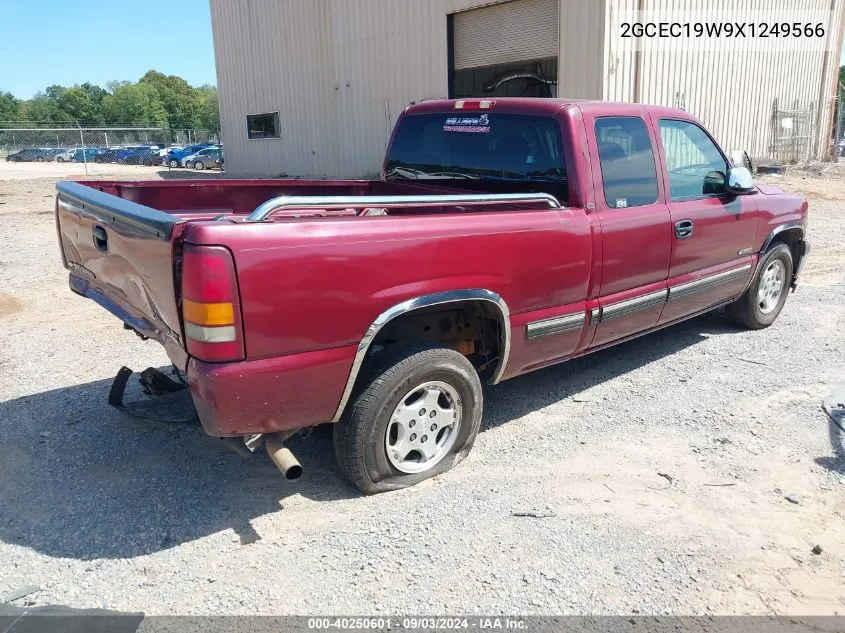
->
(210, 0), (845, 177)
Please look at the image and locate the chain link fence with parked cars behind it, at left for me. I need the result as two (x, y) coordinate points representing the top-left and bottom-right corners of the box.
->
(0, 121), (221, 166)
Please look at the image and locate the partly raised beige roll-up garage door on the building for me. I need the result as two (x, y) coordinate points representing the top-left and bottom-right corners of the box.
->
(453, 0), (560, 70)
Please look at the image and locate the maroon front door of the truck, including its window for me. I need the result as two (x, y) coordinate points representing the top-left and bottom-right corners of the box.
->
(652, 114), (757, 323)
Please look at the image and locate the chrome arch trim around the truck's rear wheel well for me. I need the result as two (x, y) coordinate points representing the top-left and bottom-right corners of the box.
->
(331, 288), (511, 422)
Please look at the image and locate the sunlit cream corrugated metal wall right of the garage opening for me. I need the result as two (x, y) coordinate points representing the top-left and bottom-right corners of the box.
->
(604, 0), (843, 158)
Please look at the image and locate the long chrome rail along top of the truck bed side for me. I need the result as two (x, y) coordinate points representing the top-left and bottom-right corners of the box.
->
(244, 193), (562, 222)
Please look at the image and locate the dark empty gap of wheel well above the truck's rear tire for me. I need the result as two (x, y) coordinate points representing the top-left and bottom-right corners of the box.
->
(370, 300), (506, 379)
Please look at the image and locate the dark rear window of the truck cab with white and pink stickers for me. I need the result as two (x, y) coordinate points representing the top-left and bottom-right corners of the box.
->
(385, 112), (566, 197)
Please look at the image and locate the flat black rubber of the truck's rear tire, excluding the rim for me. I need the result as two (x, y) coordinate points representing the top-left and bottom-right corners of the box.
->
(334, 342), (483, 494)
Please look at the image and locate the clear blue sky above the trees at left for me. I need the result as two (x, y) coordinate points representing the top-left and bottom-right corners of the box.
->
(0, 0), (217, 99)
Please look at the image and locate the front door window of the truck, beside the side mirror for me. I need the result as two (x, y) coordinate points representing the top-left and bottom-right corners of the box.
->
(660, 119), (728, 200)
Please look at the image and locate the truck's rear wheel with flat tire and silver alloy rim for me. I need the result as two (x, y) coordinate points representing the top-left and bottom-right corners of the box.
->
(334, 342), (483, 494)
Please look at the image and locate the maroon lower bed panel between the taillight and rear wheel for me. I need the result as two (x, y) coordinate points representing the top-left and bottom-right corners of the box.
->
(188, 345), (357, 437)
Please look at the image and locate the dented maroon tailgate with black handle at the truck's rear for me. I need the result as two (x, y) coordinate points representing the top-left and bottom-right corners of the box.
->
(56, 182), (185, 365)
